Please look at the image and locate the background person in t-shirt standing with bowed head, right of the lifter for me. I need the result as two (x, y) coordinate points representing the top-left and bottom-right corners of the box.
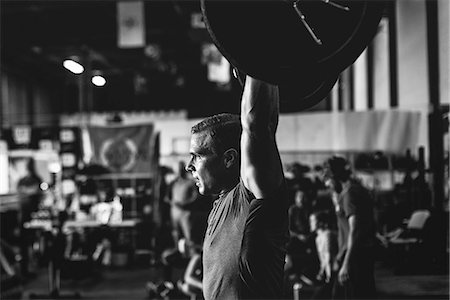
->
(324, 156), (376, 299)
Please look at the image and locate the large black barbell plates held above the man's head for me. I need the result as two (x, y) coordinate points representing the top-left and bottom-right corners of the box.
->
(201, 0), (386, 110)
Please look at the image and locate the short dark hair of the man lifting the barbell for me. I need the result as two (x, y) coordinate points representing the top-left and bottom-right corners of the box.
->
(191, 113), (242, 153)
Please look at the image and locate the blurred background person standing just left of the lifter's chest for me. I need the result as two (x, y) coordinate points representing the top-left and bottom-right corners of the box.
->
(169, 161), (198, 247)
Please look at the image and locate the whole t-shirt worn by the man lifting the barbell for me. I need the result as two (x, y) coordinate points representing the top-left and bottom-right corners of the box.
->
(203, 182), (289, 300)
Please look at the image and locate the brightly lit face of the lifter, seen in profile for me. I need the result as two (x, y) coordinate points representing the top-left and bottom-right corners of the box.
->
(186, 133), (225, 195)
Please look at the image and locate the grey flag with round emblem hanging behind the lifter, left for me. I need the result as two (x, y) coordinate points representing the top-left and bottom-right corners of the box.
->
(83, 125), (157, 173)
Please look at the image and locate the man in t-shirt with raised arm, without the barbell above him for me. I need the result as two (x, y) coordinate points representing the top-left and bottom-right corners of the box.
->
(187, 76), (288, 300)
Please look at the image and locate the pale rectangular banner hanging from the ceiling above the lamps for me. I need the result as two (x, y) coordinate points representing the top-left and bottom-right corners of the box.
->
(117, 1), (145, 48)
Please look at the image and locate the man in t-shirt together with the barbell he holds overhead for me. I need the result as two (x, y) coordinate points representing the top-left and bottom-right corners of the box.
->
(186, 0), (383, 300)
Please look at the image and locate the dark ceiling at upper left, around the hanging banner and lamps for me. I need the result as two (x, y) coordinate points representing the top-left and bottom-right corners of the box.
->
(1, 0), (250, 117)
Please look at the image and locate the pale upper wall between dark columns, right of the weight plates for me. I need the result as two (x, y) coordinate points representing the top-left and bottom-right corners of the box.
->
(346, 0), (450, 162)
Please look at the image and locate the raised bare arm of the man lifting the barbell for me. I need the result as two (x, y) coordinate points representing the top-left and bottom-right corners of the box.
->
(241, 76), (283, 198)
